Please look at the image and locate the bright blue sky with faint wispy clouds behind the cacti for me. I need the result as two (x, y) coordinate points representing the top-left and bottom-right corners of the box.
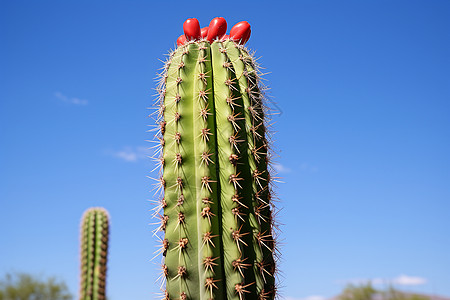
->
(0, 0), (450, 300)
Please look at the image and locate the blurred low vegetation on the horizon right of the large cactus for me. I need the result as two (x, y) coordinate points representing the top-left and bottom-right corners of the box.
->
(338, 282), (430, 300)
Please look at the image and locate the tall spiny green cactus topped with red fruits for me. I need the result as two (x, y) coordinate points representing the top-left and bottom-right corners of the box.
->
(155, 18), (277, 300)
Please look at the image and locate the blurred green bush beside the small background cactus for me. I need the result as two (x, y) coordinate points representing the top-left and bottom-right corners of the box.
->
(0, 273), (73, 300)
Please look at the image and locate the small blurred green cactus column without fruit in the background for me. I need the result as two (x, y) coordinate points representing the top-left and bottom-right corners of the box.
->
(80, 207), (109, 300)
